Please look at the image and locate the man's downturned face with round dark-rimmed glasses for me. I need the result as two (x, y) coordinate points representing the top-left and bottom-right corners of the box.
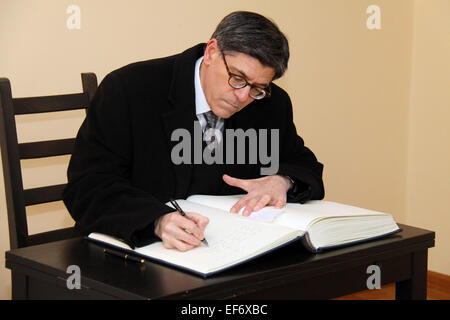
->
(200, 39), (275, 119)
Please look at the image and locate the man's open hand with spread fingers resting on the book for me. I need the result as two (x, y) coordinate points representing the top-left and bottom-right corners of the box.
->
(223, 174), (292, 216)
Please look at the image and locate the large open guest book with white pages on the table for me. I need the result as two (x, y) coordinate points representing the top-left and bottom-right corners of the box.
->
(87, 195), (401, 277)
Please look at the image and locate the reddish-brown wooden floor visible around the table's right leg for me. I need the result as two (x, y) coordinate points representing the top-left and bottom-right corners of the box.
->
(334, 271), (450, 300)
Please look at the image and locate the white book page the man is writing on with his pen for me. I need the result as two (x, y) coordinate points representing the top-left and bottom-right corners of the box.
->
(135, 200), (299, 274)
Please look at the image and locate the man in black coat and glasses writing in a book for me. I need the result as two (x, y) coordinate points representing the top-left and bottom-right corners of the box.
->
(64, 11), (324, 251)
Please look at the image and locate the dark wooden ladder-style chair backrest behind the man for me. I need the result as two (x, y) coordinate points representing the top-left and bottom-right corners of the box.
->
(0, 73), (97, 249)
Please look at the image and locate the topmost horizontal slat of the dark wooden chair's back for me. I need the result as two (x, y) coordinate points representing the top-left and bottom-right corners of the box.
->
(13, 93), (89, 115)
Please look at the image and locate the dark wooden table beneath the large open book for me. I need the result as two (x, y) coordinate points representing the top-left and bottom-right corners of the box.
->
(6, 225), (435, 299)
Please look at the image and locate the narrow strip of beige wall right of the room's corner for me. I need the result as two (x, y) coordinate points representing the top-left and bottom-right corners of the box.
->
(405, 0), (450, 274)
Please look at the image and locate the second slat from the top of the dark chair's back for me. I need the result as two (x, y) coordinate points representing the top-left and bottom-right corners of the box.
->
(19, 138), (75, 159)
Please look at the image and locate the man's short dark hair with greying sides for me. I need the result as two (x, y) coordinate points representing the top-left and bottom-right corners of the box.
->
(211, 11), (289, 80)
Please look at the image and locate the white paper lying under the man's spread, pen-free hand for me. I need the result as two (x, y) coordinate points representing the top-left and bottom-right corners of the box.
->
(187, 194), (283, 222)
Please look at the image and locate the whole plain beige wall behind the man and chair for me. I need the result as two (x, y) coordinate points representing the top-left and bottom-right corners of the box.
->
(0, 0), (450, 298)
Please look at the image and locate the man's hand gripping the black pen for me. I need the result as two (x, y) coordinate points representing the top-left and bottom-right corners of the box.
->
(155, 211), (209, 251)
